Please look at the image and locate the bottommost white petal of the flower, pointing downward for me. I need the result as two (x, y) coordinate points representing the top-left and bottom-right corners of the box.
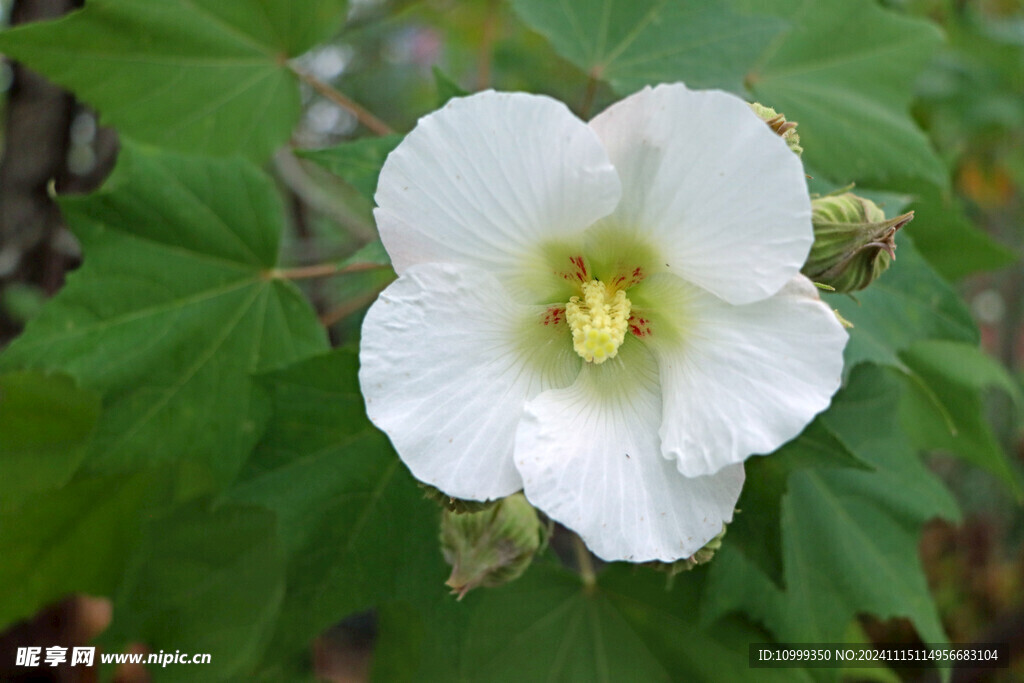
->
(515, 340), (743, 562)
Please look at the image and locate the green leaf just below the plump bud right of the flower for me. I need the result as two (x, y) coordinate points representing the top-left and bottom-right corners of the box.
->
(825, 234), (978, 374)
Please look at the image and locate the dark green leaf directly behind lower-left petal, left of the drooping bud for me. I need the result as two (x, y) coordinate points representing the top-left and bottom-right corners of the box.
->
(227, 350), (444, 656)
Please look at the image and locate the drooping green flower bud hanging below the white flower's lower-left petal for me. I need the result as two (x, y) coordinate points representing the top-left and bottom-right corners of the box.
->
(441, 494), (545, 600)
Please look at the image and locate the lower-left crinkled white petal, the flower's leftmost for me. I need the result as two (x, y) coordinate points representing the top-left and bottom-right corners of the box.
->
(359, 264), (581, 500)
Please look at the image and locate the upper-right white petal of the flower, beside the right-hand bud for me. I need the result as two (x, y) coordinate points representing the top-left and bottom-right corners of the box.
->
(591, 84), (814, 303)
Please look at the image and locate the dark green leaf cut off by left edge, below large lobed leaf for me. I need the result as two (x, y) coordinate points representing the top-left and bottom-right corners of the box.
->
(0, 372), (99, 510)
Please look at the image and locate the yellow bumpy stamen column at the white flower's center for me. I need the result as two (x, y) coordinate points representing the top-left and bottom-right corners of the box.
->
(565, 280), (632, 365)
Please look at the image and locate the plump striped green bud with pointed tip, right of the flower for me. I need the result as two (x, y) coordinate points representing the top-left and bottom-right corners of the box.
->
(801, 193), (913, 292)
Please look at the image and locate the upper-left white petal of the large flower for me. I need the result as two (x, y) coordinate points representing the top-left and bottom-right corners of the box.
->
(375, 91), (620, 294)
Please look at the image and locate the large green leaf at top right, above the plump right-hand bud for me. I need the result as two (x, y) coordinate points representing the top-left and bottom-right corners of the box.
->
(739, 0), (946, 188)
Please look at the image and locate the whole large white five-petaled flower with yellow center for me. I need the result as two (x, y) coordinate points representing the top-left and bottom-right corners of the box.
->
(359, 85), (846, 562)
